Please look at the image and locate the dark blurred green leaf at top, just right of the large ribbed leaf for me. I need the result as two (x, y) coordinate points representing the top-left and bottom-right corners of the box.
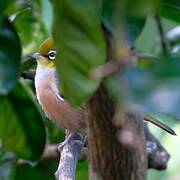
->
(102, 0), (146, 45)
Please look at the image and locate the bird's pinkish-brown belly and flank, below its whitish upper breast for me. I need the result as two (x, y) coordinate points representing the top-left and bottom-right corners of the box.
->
(37, 86), (86, 132)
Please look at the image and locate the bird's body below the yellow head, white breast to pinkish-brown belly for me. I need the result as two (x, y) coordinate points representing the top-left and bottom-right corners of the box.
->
(35, 69), (86, 132)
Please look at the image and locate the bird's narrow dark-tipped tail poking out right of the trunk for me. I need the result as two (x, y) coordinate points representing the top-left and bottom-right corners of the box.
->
(144, 114), (176, 135)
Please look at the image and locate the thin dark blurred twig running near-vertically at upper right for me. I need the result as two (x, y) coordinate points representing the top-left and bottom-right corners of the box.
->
(155, 13), (168, 55)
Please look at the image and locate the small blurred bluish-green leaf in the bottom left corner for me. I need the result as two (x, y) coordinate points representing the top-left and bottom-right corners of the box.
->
(0, 147), (16, 180)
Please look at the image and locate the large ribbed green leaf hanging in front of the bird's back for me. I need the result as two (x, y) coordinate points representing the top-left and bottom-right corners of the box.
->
(54, 0), (106, 106)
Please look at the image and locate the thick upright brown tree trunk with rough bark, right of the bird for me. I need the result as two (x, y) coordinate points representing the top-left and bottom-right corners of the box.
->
(87, 85), (147, 180)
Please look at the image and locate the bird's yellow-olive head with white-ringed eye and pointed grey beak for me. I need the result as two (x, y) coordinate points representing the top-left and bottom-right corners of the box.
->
(29, 38), (56, 69)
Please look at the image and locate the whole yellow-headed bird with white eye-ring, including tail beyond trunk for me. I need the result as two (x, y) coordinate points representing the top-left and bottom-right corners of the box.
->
(29, 38), (175, 135)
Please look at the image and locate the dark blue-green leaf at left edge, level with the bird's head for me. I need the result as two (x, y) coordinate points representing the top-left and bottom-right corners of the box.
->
(0, 18), (21, 95)
